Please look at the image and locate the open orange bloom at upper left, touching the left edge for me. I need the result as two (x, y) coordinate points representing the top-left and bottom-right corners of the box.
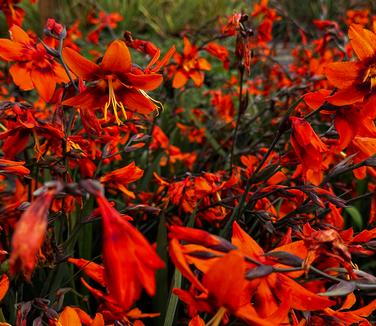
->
(0, 25), (69, 102)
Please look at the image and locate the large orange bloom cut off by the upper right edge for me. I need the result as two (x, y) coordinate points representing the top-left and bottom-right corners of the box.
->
(325, 24), (376, 106)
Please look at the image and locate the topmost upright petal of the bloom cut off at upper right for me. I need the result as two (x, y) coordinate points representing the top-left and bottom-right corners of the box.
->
(349, 24), (376, 60)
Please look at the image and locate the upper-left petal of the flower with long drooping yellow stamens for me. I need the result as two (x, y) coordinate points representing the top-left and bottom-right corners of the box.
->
(63, 48), (99, 80)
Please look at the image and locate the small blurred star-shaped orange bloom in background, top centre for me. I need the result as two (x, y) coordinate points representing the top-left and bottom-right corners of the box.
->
(172, 36), (211, 88)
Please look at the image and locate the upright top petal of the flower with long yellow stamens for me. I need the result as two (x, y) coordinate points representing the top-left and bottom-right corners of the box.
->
(101, 40), (132, 74)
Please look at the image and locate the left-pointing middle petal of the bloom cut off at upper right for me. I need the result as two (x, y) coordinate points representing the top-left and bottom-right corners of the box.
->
(325, 62), (362, 89)
